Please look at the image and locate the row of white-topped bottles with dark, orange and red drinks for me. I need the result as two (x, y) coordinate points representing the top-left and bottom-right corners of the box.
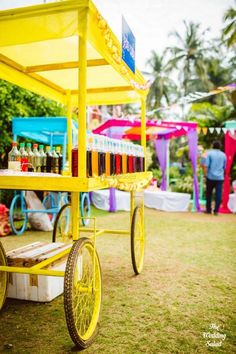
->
(72, 133), (144, 177)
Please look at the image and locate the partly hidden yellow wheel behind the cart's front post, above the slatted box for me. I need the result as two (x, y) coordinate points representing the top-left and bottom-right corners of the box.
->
(52, 204), (72, 243)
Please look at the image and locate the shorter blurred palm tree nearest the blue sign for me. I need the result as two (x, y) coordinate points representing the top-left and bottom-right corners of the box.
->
(144, 50), (175, 110)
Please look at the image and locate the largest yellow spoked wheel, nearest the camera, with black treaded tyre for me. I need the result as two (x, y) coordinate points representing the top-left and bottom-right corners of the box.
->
(64, 237), (102, 349)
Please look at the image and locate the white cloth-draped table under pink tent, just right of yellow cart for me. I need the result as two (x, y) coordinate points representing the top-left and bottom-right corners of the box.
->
(144, 190), (191, 211)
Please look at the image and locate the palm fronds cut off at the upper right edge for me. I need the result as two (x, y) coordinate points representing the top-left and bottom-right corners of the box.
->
(223, 7), (236, 47)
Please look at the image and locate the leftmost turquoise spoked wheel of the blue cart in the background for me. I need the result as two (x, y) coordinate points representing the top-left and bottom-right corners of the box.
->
(10, 194), (28, 235)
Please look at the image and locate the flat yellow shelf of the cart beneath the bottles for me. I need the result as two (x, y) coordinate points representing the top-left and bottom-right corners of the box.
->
(0, 172), (152, 192)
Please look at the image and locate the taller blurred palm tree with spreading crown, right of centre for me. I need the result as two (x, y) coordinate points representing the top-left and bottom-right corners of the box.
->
(167, 21), (209, 95)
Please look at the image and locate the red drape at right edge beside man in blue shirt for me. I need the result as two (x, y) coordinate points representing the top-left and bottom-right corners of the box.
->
(221, 120), (236, 213)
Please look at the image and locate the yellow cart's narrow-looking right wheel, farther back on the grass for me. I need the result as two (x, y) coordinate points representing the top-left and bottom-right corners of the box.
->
(131, 206), (145, 275)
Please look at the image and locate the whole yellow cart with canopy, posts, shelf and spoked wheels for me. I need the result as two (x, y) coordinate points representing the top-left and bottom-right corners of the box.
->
(0, 0), (151, 348)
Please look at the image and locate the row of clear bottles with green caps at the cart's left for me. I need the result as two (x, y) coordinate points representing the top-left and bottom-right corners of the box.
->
(8, 141), (63, 174)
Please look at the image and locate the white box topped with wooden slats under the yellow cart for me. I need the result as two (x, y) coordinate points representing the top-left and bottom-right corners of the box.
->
(7, 242), (71, 302)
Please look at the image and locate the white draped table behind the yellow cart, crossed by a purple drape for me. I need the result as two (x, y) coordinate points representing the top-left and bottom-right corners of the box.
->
(92, 189), (130, 211)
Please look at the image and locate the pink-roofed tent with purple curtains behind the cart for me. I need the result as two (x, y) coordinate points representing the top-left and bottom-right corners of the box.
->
(93, 119), (201, 211)
